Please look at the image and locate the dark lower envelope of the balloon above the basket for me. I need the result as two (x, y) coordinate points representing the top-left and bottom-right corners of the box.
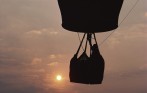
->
(58, 0), (124, 33)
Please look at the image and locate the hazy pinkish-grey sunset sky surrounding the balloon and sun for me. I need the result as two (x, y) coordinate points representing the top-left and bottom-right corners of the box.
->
(0, 0), (147, 93)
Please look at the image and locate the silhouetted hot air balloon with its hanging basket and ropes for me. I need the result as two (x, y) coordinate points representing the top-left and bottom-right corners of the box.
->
(58, 0), (124, 84)
